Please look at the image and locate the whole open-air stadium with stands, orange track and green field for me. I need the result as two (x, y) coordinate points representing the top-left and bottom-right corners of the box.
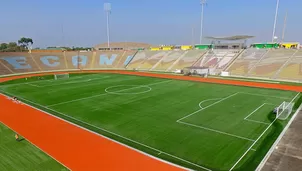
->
(0, 0), (302, 171)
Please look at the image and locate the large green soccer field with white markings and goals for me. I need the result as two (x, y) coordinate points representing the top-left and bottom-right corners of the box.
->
(0, 74), (300, 170)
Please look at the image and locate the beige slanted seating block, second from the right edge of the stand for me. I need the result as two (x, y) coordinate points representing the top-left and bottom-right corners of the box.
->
(248, 49), (297, 78)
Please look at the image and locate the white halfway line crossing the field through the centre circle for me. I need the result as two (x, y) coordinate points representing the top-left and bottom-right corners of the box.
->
(47, 80), (173, 107)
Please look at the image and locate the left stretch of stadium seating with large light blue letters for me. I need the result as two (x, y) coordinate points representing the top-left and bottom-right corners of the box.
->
(0, 50), (136, 75)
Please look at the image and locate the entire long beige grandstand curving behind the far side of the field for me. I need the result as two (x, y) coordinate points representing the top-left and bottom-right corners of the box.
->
(0, 40), (302, 82)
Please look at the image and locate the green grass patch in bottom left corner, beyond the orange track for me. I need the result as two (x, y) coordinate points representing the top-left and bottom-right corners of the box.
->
(0, 122), (67, 171)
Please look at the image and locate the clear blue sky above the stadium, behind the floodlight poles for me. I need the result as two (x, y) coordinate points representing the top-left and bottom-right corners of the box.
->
(0, 0), (302, 48)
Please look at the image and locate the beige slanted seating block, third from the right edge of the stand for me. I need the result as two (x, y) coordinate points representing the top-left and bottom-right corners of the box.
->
(227, 48), (268, 76)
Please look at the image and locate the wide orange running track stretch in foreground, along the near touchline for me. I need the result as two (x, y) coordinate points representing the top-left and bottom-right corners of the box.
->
(0, 94), (184, 171)
